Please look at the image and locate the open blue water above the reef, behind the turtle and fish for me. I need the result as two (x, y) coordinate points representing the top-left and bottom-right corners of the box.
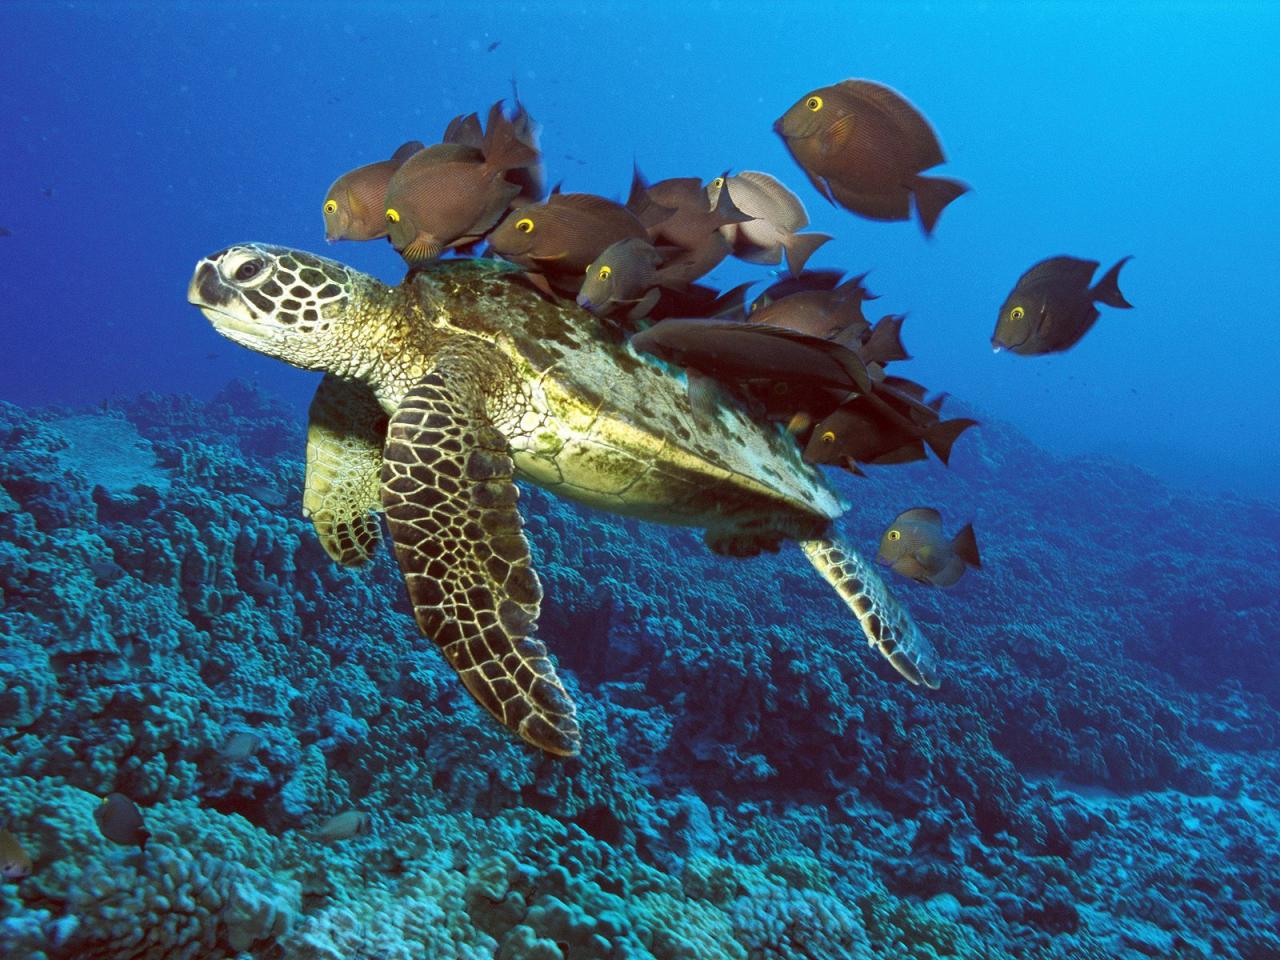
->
(0, 0), (1280, 497)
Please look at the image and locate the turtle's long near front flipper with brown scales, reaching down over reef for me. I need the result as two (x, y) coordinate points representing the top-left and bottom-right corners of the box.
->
(381, 365), (579, 756)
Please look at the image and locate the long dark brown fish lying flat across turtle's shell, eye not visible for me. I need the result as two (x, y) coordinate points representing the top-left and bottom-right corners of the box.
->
(631, 317), (870, 393)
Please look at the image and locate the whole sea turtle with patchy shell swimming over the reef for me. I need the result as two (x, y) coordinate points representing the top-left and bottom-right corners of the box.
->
(188, 243), (938, 755)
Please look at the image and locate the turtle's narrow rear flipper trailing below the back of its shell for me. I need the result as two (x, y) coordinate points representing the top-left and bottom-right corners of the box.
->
(800, 540), (941, 690)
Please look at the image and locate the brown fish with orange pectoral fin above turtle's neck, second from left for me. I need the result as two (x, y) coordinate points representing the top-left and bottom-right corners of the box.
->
(384, 102), (538, 264)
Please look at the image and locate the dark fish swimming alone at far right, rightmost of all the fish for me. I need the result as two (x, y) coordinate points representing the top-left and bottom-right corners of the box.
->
(991, 256), (1133, 356)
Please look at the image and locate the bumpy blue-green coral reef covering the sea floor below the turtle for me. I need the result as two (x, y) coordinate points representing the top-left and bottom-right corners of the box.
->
(0, 383), (1280, 960)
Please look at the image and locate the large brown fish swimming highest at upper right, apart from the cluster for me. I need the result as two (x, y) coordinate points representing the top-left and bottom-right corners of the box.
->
(773, 79), (969, 234)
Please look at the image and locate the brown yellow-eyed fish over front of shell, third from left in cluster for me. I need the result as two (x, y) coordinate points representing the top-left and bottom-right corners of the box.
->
(489, 193), (649, 296)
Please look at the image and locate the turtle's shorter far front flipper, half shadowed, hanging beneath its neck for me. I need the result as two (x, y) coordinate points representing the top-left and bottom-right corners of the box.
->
(302, 374), (387, 567)
